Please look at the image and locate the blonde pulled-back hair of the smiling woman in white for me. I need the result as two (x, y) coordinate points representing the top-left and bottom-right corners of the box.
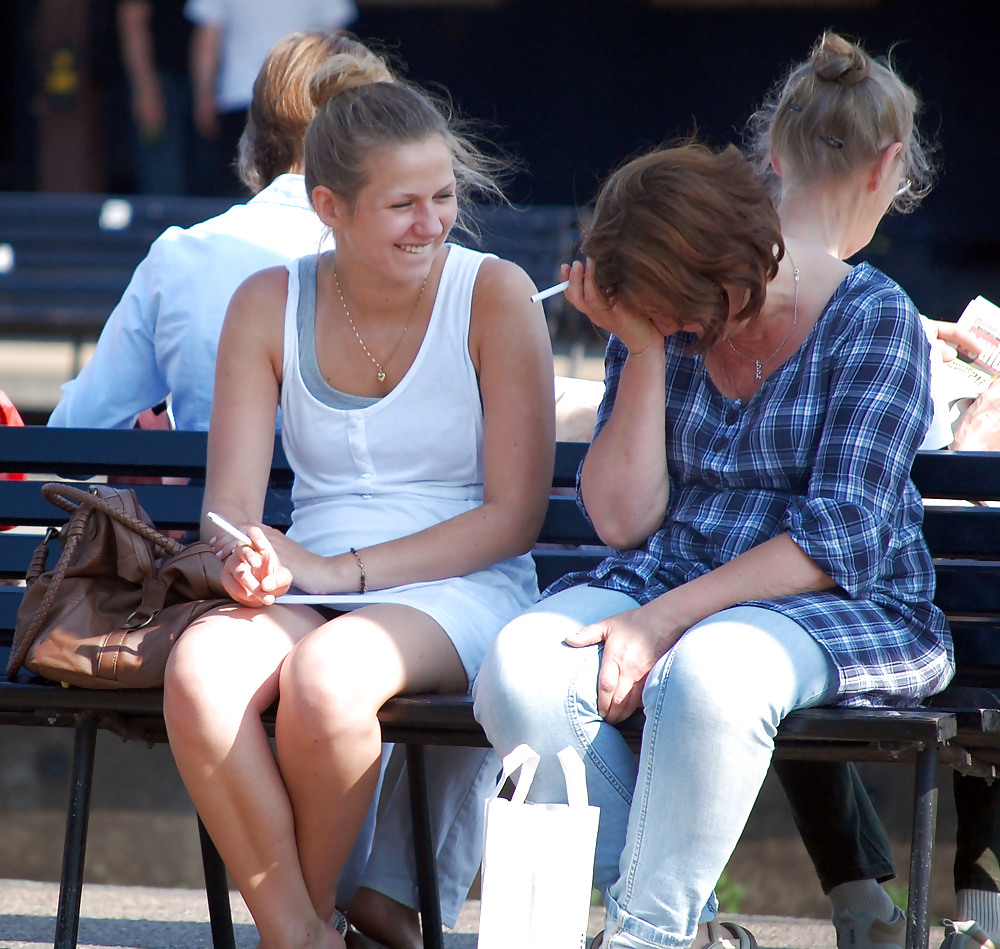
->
(305, 67), (510, 228)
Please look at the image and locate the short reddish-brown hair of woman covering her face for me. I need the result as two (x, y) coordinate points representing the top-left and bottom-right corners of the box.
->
(581, 141), (785, 351)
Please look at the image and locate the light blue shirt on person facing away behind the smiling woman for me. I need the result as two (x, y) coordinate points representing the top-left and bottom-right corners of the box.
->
(48, 174), (332, 432)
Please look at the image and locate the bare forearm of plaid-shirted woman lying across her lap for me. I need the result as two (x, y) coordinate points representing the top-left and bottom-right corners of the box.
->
(642, 534), (836, 629)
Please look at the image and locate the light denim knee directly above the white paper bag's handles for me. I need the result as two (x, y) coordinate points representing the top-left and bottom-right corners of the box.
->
(473, 613), (596, 754)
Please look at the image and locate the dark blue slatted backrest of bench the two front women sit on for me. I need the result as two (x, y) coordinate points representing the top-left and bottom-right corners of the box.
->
(0, 426), (1000, 686)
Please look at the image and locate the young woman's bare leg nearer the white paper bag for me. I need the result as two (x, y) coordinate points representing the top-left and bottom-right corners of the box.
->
(275, 604), (467, 936)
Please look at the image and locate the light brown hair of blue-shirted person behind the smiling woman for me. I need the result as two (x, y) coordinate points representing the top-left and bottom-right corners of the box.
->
(237, 31), (393, 194)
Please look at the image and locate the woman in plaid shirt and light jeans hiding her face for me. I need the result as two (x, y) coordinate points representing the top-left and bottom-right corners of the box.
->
(473, 144), (954, 949)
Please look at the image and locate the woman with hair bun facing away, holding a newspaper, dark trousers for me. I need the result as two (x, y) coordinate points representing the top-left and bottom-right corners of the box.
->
(748, 33), (1000, 949)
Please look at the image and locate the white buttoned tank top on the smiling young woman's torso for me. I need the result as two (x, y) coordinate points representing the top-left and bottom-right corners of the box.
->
(281, 245), (485, 556)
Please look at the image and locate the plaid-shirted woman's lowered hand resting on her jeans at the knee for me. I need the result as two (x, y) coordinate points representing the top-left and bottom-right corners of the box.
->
(566, 608), (683, 725)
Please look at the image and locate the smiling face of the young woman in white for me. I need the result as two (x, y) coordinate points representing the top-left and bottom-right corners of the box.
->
(330, 135), (458, 283)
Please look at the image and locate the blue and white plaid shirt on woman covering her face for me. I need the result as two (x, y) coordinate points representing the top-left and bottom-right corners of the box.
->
(546, 264), (954, 705)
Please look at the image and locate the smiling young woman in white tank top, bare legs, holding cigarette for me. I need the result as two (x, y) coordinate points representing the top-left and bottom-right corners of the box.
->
(164, 74), (554, 949)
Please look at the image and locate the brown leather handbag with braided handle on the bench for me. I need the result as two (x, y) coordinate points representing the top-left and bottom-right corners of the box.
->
(7, 483), (233, 689)
